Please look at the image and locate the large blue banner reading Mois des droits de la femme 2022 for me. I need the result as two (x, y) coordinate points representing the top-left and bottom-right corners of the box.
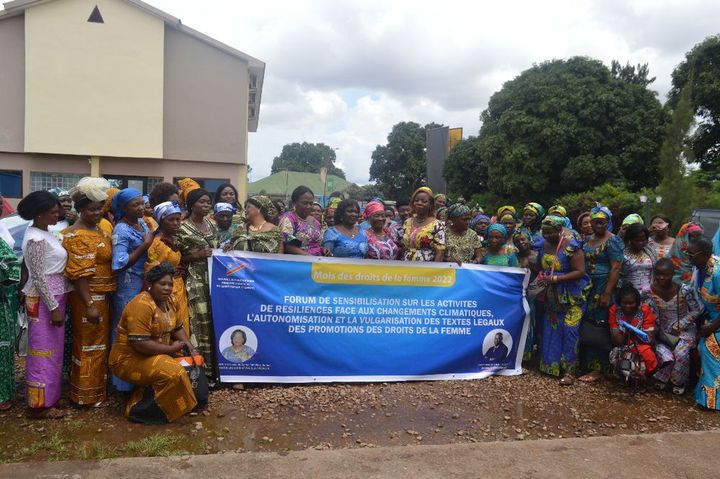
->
(209, 250), (529, 383)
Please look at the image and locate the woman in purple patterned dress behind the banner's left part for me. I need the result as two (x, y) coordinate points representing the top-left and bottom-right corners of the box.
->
(278, 186), (324, 256)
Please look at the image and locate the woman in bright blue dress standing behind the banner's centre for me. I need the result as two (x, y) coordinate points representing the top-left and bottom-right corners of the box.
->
(323, 200), (372, 258)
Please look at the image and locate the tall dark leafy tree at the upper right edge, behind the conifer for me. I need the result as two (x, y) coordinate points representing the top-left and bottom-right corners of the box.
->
(668, 35), (720, 174)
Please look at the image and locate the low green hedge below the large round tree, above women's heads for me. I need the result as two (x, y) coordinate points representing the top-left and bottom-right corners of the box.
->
(548, 183), (644, 226)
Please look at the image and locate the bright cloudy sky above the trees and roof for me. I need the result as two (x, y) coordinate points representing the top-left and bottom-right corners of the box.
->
(146, 0), (720, 184)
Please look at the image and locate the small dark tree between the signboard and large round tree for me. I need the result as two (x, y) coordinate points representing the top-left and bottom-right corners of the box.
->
(443, 136), (488, 198)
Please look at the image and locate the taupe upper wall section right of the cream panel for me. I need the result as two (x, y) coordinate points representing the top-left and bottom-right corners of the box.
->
(164, 28), (248, 168)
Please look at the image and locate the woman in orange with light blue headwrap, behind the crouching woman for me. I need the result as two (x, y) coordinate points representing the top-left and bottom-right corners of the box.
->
(145, 201), (191, 338)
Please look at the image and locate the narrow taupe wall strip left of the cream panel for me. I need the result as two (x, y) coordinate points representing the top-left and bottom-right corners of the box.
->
(0, 15), (25, 151)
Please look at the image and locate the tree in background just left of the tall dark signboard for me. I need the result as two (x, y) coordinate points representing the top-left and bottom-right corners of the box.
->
(370, 121), (443, 200)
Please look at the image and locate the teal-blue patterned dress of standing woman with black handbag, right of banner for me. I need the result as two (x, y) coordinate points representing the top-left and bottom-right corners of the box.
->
(580, 236), (625, 373)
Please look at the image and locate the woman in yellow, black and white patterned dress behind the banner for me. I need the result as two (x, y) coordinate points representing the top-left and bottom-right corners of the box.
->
(403, 186), (445, 262)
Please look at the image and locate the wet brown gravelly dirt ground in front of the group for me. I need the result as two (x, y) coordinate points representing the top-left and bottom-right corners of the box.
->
(0, 372), (720, 462)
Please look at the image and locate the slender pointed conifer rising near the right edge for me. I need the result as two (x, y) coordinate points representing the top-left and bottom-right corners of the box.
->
(658, 80), (695, 225)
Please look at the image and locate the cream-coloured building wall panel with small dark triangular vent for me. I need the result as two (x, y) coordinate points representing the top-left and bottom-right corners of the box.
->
(25, 0), (165, 158)
